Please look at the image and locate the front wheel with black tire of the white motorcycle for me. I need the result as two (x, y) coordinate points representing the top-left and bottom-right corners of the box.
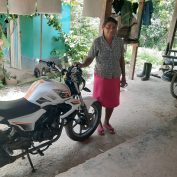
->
(65, 102), (101, 141)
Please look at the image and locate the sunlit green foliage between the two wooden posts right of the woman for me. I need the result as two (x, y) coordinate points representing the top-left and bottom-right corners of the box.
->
(140, 0), (175, 50)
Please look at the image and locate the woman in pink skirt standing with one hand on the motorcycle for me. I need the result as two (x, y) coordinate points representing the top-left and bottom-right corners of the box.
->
(79, 17), (126, 135)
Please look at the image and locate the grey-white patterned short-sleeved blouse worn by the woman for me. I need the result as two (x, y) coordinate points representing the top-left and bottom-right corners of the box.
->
(88, 36), (124, 79)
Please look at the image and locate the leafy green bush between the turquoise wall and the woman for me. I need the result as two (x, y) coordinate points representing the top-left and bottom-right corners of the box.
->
(47, 2), (99, 61)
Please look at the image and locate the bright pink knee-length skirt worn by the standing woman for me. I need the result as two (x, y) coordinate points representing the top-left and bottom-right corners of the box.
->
(93, 73), (120, 108)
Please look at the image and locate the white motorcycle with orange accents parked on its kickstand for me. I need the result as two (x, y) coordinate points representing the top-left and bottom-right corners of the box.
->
(0, 62), (101, 171)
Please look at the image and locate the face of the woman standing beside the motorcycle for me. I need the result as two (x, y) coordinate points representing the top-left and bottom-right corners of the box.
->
(102, 22), (117, 37)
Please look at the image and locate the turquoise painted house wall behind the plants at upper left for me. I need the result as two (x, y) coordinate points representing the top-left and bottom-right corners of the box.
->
(20, 5), (71, 60)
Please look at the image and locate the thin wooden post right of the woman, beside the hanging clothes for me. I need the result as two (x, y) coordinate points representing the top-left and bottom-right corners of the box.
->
(129, 0), (145, 80)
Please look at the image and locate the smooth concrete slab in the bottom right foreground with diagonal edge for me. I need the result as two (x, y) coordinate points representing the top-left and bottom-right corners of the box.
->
(56, 119), (177, 177)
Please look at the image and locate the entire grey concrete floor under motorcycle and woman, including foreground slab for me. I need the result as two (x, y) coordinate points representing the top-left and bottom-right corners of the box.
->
(0, 77), (177, 177)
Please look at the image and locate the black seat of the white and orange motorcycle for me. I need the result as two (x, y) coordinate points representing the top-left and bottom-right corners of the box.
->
(0, 98), (41, 120)
